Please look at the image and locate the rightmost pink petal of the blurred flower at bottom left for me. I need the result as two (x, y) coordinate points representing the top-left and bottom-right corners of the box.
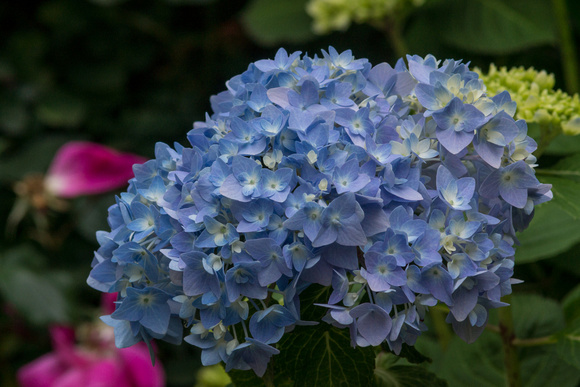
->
(119, 343), (165, 387)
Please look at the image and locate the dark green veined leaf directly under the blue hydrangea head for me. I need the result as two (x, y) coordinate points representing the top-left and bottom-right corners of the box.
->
(275, 323), (375, 387)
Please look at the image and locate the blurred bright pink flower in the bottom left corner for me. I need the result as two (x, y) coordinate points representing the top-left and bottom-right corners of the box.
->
(18, 325), (165, 387)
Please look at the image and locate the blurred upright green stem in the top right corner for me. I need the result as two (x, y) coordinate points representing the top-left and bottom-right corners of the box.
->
(552, 0), (580, 94)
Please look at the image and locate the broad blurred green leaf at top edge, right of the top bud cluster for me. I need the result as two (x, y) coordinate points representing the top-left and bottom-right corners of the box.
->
(408, 0), (558, 54)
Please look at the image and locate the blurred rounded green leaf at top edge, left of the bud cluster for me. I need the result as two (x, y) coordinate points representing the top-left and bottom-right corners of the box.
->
(242, 0), (314, 46)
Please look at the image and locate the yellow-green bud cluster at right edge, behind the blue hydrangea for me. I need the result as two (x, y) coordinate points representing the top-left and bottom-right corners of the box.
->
(475, 64), (580, 136)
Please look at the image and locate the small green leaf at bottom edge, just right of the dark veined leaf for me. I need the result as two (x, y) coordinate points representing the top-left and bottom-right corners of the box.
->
(375, 354), (447, 387)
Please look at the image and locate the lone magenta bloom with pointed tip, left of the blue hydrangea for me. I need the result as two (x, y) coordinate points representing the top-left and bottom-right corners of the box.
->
(45, 141), (146, 198)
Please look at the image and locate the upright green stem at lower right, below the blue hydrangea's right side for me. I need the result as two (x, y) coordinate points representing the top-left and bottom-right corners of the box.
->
(499, 295), (522, 387)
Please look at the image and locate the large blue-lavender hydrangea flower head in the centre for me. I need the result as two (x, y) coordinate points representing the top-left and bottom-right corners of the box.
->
(88, 47), (551, 375)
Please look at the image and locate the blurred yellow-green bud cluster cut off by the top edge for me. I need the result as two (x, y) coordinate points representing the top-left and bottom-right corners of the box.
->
(306, 0), (425, 34)
